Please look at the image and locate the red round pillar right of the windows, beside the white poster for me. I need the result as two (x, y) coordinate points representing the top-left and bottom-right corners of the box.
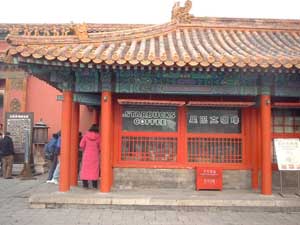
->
(260, 95), (272, 195)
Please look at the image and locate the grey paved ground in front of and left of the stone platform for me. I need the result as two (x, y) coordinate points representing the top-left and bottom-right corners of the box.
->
(0, 176), (300, 225)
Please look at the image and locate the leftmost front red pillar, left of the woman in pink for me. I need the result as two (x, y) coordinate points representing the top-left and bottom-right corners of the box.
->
(59, 91), (73, 192)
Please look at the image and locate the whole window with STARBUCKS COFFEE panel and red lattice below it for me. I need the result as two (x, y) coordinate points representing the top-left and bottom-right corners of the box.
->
(121, 105), (178, 162)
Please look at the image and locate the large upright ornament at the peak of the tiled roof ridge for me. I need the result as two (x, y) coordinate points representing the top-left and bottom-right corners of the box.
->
(171, 0), (194, 23)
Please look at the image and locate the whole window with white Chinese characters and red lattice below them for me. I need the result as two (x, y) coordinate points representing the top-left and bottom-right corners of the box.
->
(187, 107), (243, 164)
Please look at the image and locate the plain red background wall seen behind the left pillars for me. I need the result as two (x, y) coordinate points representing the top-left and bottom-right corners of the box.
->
(26, 76), (93, 138)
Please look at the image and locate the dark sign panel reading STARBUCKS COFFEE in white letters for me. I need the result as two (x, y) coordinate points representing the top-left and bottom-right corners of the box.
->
(122, 106), (178, 132)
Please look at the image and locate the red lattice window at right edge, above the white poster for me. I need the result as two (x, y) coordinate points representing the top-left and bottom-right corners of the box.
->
(272, 109), (300, 133)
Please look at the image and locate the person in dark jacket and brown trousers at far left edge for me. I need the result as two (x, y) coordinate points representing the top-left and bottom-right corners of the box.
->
(1, 132), (15, 179)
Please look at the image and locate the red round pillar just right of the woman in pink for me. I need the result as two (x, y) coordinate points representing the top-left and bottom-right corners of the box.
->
(100, 91), (112, 192)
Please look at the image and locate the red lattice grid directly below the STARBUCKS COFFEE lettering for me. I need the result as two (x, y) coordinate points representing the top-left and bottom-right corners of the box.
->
(121, 136), (177, 162)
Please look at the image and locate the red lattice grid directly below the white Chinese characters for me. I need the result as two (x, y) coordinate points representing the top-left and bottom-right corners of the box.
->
(188, 137), (242, 163)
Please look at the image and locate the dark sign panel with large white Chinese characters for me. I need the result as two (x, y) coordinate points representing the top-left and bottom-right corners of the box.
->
(187, 108), (241, 133)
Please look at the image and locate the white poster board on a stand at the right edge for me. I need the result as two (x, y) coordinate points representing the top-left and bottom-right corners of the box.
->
(274, 138), (300, 170)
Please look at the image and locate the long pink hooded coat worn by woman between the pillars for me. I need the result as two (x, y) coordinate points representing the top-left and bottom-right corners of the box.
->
(80, 131), (100, 180)
